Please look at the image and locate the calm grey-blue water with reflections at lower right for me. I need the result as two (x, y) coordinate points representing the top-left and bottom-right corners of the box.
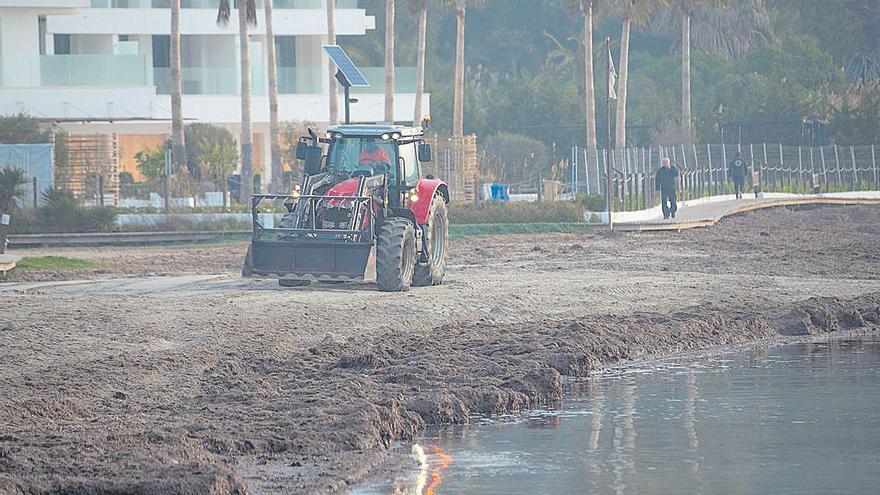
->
(358, 337), (880, 494)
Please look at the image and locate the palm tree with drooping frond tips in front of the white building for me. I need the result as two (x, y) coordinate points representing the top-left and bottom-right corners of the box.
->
(217, 0), (257, 202)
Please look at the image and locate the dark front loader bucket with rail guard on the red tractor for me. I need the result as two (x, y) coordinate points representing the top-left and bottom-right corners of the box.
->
(242, 189), (376, 281)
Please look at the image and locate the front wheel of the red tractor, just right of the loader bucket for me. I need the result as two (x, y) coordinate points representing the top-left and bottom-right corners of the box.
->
(376, 217), (416, 292)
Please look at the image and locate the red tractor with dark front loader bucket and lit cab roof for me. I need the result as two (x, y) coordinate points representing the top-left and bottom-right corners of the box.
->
(242, 125), (449, 291)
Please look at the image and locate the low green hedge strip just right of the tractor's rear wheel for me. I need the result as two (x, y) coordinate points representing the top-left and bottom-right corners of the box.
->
(449, 201), (584, 224)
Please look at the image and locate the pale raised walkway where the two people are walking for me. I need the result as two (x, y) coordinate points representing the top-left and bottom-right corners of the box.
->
(614, 191), (880, 230)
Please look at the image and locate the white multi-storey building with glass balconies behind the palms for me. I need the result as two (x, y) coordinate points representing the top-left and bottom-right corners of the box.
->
(0, 0), (428, 184)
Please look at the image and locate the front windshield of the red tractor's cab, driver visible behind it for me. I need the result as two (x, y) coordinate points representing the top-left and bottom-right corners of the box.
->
(327, 137), (397, 184)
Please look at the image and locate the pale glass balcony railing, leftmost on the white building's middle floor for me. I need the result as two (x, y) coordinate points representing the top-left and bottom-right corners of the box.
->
(40, 55), (153, 86)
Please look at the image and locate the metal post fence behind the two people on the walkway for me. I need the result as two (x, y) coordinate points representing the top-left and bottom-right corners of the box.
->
(566, 143), (880, 210)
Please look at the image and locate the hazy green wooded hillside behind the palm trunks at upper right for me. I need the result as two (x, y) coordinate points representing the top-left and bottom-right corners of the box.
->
(348, 0), (880, 152)
